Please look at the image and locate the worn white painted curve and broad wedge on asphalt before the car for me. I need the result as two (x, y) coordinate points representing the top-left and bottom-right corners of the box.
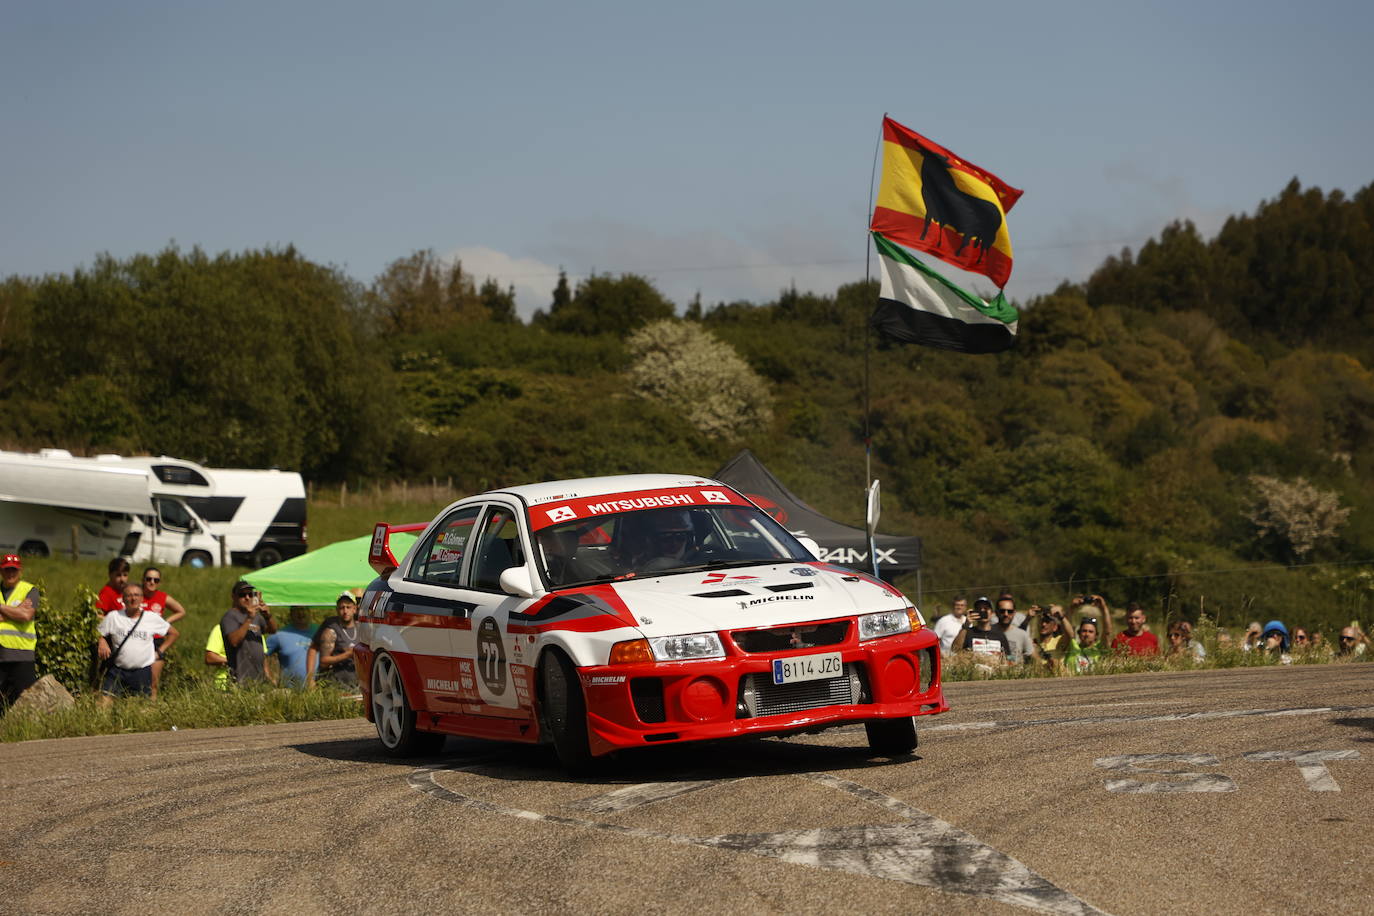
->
(408, 765), (1102, 915)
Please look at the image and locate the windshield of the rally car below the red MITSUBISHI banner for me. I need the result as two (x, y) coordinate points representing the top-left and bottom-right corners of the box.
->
(536, 505), (815, 588)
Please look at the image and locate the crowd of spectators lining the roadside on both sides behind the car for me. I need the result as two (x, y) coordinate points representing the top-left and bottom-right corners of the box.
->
(0, 553), (1374, 710)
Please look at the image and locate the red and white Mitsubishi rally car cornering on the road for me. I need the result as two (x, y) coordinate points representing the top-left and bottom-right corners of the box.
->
(354, 474), (948, 769)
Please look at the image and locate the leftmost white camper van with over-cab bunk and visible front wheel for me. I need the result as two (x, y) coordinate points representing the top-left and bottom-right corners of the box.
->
(0, 449), (220, 566)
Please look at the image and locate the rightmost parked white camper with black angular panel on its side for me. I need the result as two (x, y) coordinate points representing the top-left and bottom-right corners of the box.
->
(199, 467), (305, 569)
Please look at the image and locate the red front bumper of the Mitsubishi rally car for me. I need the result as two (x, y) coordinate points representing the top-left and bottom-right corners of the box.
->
(577, 629), (949, 754)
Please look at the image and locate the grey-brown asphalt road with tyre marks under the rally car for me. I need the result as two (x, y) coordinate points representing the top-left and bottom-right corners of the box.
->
(0, 665), (1374, 913)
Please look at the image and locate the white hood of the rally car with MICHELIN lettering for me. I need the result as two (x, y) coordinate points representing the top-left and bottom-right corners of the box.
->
(613, 563), (907, 637)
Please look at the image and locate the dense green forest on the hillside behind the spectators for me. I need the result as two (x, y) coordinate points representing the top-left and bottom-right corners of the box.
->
(0, 180), (1374, 626)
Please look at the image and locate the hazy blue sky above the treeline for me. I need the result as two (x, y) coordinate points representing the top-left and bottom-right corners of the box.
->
(0, 0), (1374, 314)
